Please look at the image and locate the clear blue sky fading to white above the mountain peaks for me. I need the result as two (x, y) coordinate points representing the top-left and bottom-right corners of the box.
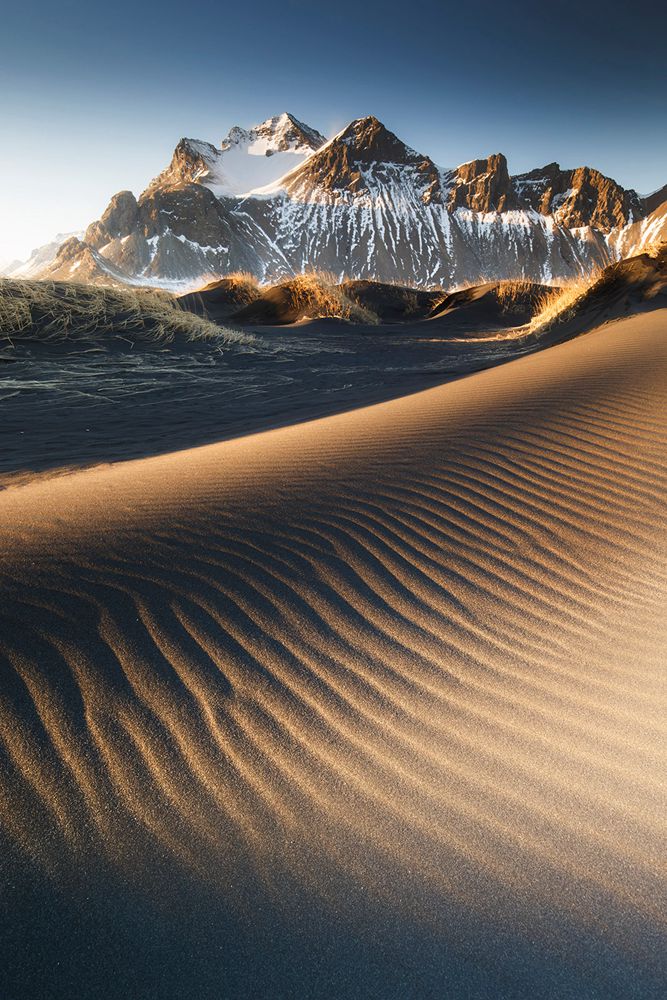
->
(0, 0), (667, 260)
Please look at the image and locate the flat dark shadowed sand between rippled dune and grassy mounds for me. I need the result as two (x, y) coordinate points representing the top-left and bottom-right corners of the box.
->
(0, 320), (536, 487)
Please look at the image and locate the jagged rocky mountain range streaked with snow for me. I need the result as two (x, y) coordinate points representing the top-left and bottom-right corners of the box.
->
(28, 114), (667, 287)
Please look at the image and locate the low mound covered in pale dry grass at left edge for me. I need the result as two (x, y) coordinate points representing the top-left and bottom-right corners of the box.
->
(0, 278), (248, 344)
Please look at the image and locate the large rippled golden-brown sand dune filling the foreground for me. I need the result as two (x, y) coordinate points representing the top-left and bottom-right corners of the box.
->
(0, 311), (667, 998)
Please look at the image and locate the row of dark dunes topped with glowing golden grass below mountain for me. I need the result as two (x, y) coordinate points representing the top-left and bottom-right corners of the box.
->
(178, 244), (667, 343)
